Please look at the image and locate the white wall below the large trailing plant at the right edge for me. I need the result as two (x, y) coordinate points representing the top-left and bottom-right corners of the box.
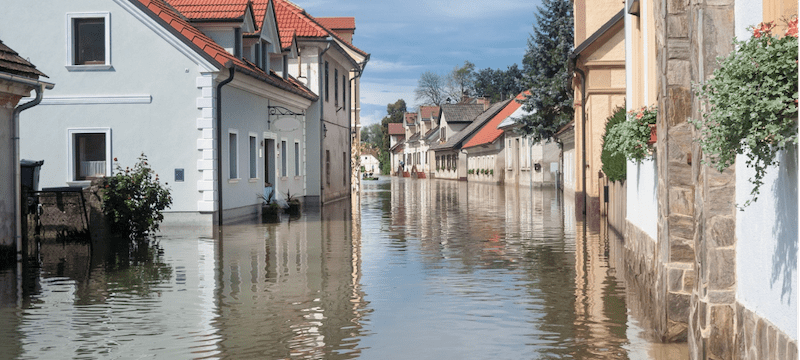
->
(736, 148), (800, 341)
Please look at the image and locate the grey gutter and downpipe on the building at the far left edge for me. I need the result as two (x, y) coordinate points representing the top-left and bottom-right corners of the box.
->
(0, 74), (55, 261)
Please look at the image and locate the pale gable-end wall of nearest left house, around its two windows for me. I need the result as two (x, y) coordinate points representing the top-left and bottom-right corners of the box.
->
(0, 0), (202, 212)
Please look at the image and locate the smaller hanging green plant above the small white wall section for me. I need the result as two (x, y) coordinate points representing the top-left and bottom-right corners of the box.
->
(603, 105), (658, 164)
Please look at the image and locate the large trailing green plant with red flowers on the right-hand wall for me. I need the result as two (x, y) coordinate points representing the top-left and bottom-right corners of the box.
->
(692, 21), (799, 206)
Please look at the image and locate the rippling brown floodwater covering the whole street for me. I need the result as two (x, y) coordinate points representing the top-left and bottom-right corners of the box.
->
(0, 178), (688, 359)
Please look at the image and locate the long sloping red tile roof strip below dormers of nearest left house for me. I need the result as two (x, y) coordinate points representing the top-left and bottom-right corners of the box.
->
(130, 0), (318, 101)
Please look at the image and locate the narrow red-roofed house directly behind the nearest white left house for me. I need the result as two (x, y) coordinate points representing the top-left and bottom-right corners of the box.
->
(280, 0), (369, 205)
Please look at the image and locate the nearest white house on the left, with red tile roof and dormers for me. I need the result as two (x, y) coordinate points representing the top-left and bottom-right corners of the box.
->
(0, 0), (318, 231)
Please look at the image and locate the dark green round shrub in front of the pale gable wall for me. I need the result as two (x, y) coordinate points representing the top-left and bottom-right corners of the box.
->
(103, 153), (172, 238)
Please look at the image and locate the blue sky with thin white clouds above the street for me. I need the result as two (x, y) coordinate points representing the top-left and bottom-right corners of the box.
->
(292, 0), (540, 126)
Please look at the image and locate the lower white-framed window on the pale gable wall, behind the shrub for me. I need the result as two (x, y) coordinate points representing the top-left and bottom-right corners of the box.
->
(67, 128), (111, 181)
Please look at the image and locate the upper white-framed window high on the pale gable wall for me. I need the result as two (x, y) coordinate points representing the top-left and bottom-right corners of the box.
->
(66, 12), (111, 70)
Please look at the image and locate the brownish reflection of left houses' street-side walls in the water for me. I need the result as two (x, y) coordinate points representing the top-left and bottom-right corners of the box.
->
(214, 201), (363, 358)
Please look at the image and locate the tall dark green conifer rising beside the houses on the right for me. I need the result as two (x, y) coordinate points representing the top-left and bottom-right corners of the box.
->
(522, 0), (575, 142)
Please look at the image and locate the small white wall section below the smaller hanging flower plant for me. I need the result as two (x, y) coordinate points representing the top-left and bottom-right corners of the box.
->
(626, 160), (658, 240)
